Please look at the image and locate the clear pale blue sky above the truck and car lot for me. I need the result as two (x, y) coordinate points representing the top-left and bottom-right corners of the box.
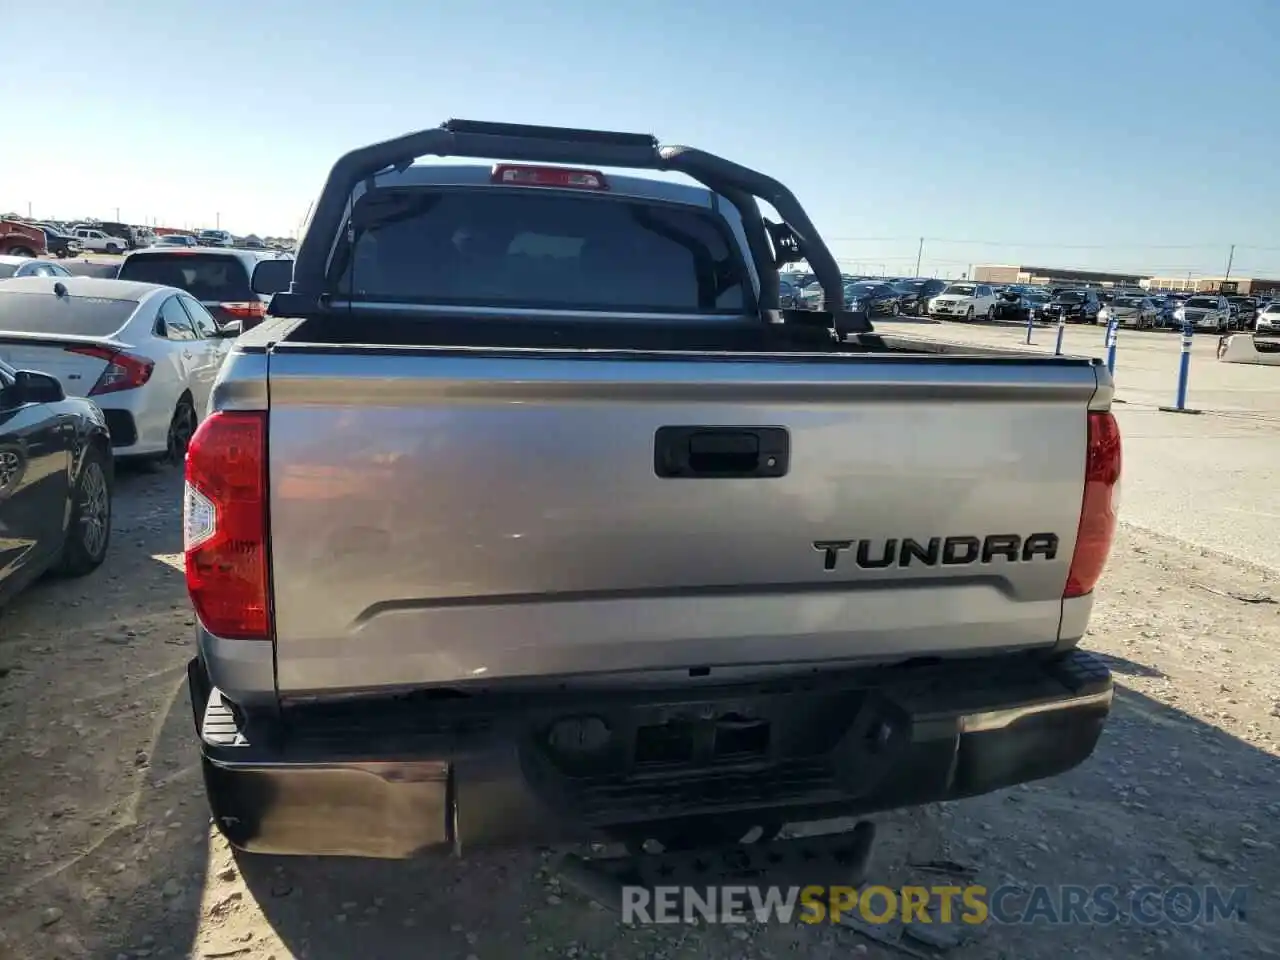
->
(0, 0), (1280, 276)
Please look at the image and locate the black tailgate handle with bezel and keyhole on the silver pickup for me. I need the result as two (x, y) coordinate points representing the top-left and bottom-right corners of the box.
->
(654, 426), (790, 479)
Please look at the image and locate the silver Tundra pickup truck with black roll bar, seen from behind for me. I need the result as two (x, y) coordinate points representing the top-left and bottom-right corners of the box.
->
(184, 120), (1120, 896)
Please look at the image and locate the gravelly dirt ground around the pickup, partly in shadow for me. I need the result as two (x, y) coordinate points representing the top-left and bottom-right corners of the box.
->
(0, 471), (1280, 960)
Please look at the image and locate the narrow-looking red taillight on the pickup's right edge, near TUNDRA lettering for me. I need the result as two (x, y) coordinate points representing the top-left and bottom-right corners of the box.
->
(1062, 412), (1121, 598)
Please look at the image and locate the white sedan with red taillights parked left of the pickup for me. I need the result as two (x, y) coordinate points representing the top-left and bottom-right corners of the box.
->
(0, 276), (237, 462)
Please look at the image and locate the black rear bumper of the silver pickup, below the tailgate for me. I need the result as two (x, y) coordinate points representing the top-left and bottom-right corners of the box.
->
(188, 650), (1112, 858)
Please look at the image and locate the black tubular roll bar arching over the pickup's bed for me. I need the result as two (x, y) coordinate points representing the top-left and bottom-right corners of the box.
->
(289, 120), (872, 333)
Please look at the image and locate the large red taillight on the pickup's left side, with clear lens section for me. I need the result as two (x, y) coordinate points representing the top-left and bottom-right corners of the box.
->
(182, 411), (271, 640)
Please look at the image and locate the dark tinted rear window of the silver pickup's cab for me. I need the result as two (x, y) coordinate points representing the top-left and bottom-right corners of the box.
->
(334, 189), (751, 314)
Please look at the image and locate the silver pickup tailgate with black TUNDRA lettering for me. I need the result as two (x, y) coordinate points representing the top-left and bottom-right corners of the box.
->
(269, 344), (1097, 696)
